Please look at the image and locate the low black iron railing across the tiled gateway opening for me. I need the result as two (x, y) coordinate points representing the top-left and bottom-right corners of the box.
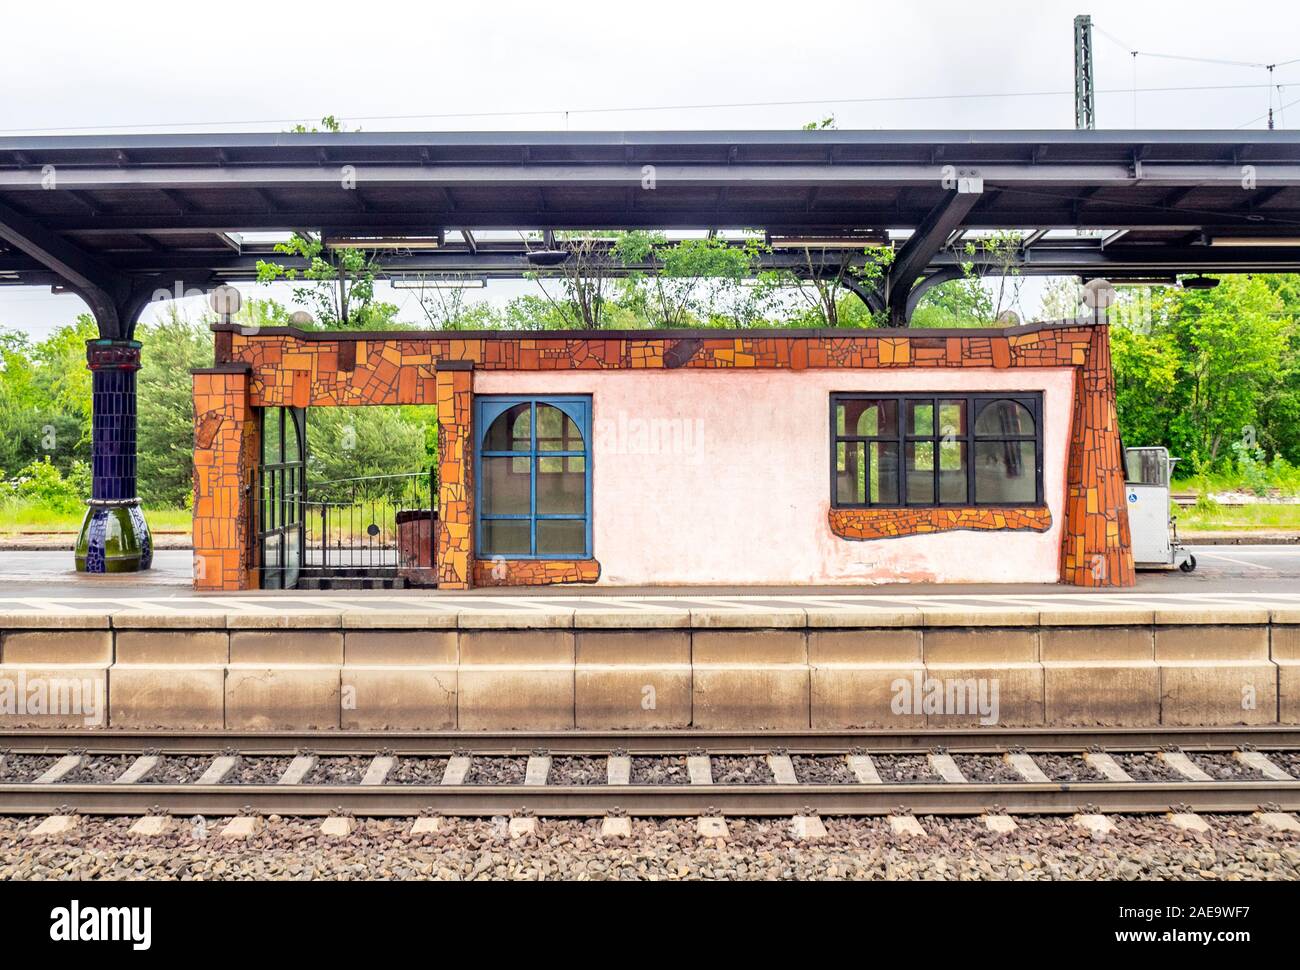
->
(303, 469), (437, 572)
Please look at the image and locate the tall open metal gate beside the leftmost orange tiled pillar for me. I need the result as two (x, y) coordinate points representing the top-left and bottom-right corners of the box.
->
(251, 407), (307, 589)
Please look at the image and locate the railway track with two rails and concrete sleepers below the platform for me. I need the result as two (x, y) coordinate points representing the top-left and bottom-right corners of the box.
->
(0, 728), (1300, 817)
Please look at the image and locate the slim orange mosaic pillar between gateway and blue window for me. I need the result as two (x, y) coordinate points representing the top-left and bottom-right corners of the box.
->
(436, 360), (475, 589)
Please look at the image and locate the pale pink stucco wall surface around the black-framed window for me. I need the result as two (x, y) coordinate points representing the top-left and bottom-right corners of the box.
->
(475, 368), (1074, 585)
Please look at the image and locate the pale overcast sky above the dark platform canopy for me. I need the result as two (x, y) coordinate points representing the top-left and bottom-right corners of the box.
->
(0, 0), (1300, 335)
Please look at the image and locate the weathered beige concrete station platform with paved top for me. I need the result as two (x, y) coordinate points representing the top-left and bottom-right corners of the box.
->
(0, 581), (1300, 732)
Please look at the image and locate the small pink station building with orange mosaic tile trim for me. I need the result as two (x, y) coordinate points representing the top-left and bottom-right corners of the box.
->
(194, 322), (1134, 590)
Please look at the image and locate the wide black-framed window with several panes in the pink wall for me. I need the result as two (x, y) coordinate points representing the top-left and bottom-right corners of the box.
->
(831, 391), (1043, 508)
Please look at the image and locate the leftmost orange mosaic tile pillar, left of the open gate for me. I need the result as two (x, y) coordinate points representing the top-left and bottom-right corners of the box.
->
(194, 364), (261, 590)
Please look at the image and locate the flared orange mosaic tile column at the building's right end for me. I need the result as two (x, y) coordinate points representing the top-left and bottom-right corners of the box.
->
(1061, 324), (1136, 586)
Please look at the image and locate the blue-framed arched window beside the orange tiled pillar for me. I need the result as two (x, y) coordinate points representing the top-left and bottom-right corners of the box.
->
(475, 395), (592, 559)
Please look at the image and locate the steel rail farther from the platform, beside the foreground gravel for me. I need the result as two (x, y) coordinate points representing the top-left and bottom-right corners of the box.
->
(0, 781), (1300, 818)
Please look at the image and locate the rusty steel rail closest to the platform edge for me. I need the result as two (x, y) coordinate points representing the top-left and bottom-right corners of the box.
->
(0, 726), (1300, 755)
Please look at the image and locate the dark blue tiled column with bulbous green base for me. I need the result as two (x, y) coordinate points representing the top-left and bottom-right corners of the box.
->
(75, 339), (153, 572)
